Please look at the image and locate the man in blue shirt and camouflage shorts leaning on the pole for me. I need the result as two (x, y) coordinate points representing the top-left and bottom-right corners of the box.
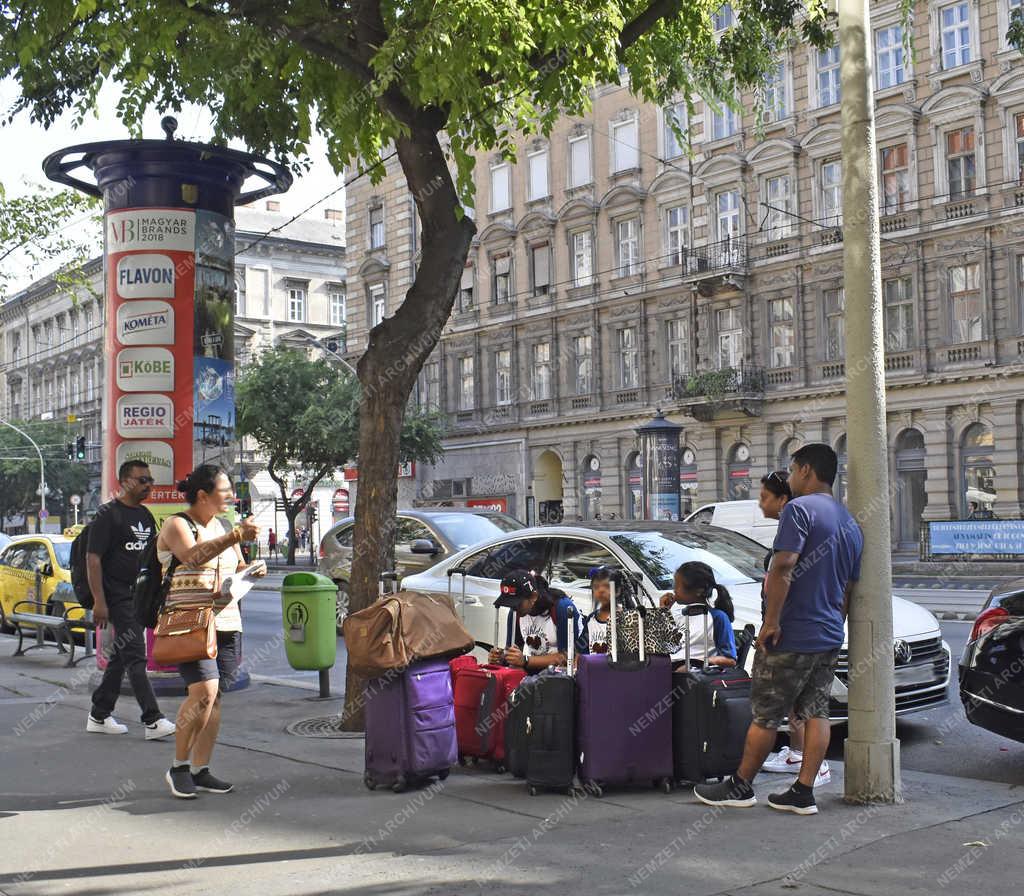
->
(694, 444), (864, 815)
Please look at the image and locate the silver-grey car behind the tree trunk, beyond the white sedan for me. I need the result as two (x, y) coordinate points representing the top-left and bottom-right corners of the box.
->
(317, 507), (523, 635)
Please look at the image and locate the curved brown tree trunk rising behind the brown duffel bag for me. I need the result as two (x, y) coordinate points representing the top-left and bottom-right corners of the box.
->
(342, 128), (476, 731)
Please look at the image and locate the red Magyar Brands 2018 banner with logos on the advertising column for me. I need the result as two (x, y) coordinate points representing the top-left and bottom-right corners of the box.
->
(103, 209), (196, 504)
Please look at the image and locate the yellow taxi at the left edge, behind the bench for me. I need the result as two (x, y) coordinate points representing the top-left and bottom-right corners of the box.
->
(0, 535), (78, 631)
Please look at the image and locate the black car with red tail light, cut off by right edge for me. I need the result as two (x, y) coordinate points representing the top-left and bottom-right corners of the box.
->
(959, 579), (1024, 742)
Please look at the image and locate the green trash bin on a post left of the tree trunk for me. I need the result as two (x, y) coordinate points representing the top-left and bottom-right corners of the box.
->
(281, 572), (338, 671)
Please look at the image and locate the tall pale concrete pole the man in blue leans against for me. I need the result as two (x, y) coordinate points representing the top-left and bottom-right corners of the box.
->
(839, 0), (902, 803)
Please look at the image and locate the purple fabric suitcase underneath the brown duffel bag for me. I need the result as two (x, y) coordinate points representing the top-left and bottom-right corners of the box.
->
(362, 659), (459, 794)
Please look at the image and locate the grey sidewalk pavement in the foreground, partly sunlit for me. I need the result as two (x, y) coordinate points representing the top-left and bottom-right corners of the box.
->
(0, 638), (1024, 896)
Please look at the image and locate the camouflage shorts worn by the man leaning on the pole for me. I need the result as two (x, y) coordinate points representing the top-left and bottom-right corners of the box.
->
(751, 650), (839, 729)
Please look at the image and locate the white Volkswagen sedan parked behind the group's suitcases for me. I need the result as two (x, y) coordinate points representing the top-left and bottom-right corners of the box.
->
(401, 520), (950, 720)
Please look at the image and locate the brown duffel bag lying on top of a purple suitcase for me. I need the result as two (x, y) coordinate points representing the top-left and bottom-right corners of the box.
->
(342, 591), (473, 677)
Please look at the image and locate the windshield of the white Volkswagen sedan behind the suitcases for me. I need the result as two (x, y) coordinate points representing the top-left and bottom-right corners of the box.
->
(611, 528), (765, 591)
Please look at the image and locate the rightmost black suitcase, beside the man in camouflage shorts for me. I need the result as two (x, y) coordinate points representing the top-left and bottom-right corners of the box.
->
(672, 606), (753, 781)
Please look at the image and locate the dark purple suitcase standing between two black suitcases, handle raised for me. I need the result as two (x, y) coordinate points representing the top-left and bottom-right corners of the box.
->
(577, 583), (673, 796)
